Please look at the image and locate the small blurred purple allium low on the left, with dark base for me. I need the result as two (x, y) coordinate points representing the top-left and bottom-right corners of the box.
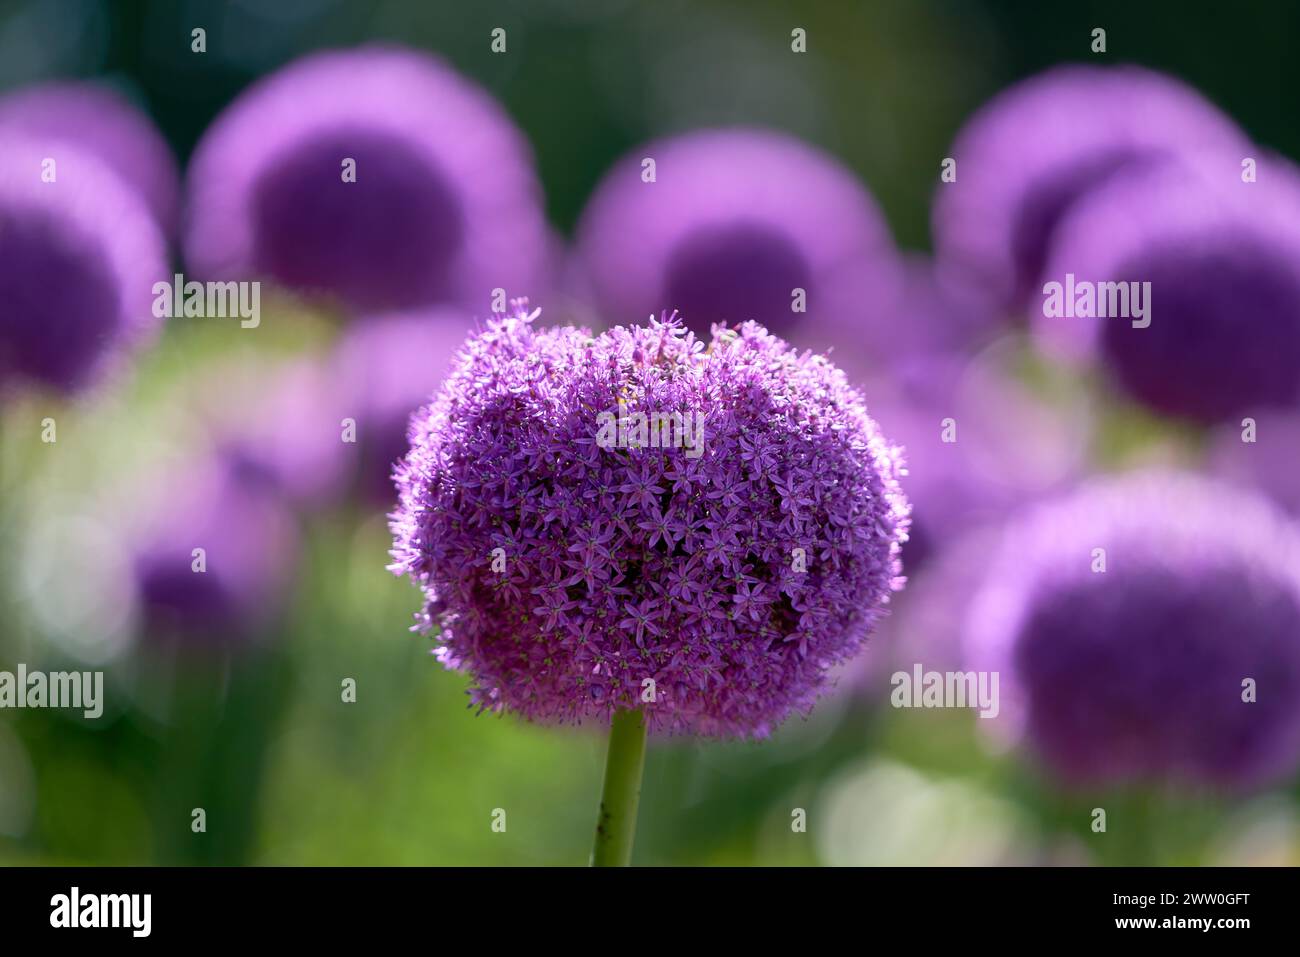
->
(134, 459), (298, 646)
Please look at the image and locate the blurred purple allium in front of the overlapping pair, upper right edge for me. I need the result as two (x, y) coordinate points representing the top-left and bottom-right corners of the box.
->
(1035, 153), (1300, 423)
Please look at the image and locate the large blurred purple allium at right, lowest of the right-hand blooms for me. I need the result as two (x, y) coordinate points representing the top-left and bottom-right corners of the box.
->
(967, 471), (1300, 785)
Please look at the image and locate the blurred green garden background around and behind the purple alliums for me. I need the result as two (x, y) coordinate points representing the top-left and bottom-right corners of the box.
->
(0, 0), (1300, 865)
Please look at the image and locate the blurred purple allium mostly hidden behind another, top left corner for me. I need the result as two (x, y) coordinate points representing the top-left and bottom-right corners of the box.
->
(0, 82), (181, 237)
